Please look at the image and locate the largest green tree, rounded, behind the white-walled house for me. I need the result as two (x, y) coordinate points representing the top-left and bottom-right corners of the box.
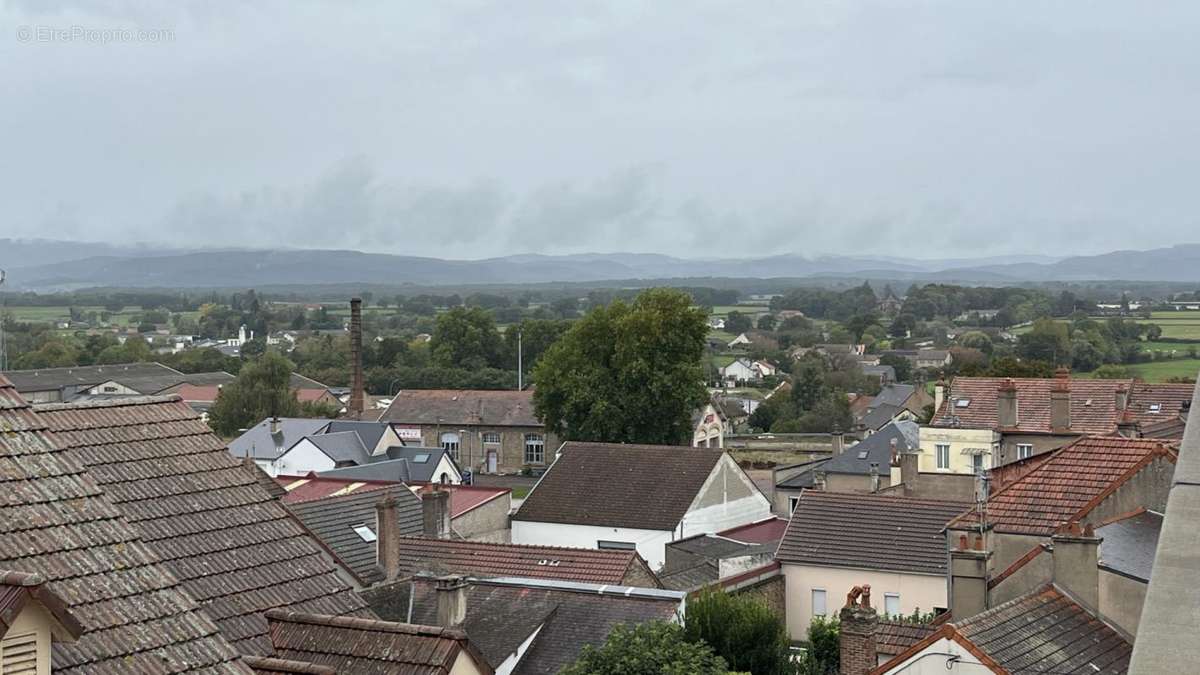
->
(533, 288), (708, 444)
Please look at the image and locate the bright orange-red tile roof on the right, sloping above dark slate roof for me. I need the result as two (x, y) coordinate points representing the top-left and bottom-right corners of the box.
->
(950, 436), (1176, 536)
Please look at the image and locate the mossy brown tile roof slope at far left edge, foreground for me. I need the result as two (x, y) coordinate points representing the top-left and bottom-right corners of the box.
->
(0, 376), (250, 675)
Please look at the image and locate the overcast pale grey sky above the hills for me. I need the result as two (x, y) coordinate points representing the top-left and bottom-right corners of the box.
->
(0, 0), (1200, 257)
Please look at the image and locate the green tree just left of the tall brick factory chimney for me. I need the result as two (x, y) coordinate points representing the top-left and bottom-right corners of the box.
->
(209, 351), (301, 436)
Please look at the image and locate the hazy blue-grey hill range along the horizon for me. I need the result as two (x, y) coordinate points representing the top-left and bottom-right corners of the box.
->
(0, 239), (1200, 291)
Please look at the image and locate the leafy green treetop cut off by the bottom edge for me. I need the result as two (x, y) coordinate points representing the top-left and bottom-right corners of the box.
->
(559, 621), (728, 675)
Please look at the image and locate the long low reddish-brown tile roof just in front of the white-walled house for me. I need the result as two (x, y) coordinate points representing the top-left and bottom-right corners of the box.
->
(386, 537), (649, 584)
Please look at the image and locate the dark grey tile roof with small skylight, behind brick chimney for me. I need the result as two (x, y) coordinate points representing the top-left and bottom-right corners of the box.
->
(287, 485), (422, 584)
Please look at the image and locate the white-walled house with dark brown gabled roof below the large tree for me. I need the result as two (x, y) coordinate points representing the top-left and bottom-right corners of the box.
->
(512, 442), (770, 569)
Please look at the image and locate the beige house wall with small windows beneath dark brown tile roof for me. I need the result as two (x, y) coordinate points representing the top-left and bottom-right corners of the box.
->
(784, 562), (947, 640)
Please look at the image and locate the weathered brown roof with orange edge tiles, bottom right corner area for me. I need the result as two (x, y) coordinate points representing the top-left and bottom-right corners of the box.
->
(954, 587), (1133, 674)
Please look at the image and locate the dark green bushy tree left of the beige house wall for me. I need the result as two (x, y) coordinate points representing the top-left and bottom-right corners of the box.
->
(684, 589), (794, 675)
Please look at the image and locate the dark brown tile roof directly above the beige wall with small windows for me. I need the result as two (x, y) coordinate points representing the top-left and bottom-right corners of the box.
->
(775, 490), (966, 574)
